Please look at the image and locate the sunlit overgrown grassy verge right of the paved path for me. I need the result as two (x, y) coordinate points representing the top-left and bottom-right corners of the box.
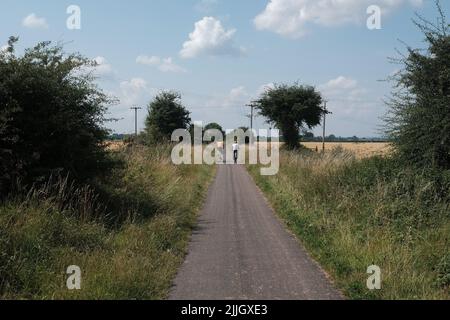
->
(249, 151), (450, 299)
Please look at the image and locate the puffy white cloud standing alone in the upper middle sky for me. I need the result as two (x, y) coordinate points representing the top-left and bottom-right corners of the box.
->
(180, 17), (245, 59)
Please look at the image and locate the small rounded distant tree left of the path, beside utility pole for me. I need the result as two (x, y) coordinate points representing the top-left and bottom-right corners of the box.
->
(145, 91), (191, 143)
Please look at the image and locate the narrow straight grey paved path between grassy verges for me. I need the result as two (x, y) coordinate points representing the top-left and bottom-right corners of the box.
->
(169, 165), (342, 300)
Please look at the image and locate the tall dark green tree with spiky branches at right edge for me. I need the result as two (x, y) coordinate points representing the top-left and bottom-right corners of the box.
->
(386, 1), (450, 169)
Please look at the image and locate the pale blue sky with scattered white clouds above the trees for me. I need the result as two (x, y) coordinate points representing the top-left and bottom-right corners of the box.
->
(0, 0), (450, 136)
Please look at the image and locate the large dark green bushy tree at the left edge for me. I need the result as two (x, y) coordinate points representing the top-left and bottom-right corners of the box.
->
(0, 37), (113, 195)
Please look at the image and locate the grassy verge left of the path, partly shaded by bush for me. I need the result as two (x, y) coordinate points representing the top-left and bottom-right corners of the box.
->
(0, 147), (214, 299)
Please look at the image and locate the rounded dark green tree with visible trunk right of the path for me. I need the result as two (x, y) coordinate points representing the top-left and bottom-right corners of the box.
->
(256, 84), (326, 149)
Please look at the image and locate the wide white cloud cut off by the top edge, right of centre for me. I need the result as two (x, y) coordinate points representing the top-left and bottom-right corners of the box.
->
(254, 0), (423, 38)
